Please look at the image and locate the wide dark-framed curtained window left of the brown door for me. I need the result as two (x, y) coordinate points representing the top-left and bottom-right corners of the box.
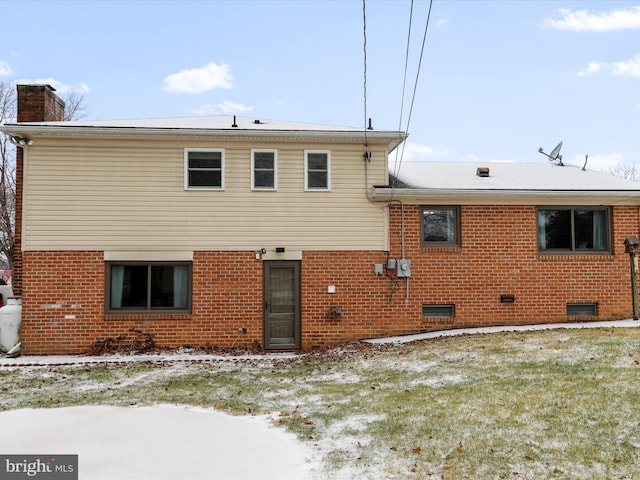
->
(105, 262), (191, 313)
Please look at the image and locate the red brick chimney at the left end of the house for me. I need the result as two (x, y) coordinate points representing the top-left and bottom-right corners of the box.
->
(12, 85), (65, 295)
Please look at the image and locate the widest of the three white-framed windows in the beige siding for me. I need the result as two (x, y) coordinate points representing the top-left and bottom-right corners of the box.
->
(184, 148), (224, 190)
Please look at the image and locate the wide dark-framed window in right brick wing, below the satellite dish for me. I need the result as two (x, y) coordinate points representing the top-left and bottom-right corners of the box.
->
(538, 207), (611, 253)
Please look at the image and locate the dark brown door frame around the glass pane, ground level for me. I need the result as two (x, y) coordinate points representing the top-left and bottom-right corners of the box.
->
(262, 260), (302, 350)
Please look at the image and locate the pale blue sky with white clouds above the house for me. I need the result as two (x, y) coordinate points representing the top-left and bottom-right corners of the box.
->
(0, 0), (640, 169)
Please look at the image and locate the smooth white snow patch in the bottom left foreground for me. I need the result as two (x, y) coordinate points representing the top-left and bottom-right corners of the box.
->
(0, 405), (313, 480)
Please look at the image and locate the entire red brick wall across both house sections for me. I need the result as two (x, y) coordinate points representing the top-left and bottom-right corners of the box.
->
(22, 206), (638, 354)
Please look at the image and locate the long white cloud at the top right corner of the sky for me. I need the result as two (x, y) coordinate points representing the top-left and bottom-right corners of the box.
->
(542, 6), (640, 32)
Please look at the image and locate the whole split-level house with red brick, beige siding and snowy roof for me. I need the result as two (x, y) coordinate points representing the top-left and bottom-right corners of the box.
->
(0, 85), (640, 354)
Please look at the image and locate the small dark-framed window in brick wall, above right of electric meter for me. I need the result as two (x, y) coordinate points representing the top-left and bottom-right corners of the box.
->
(420, 205), (460, 247)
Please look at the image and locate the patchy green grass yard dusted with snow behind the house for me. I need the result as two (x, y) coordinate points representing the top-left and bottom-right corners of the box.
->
(0, 328), (640, 480)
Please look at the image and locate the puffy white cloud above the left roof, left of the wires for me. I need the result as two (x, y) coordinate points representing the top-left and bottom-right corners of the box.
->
(163, 62), (233, 93)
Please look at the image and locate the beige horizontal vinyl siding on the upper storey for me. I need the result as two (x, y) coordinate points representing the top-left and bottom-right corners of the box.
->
(23, 138), (388, 251)
